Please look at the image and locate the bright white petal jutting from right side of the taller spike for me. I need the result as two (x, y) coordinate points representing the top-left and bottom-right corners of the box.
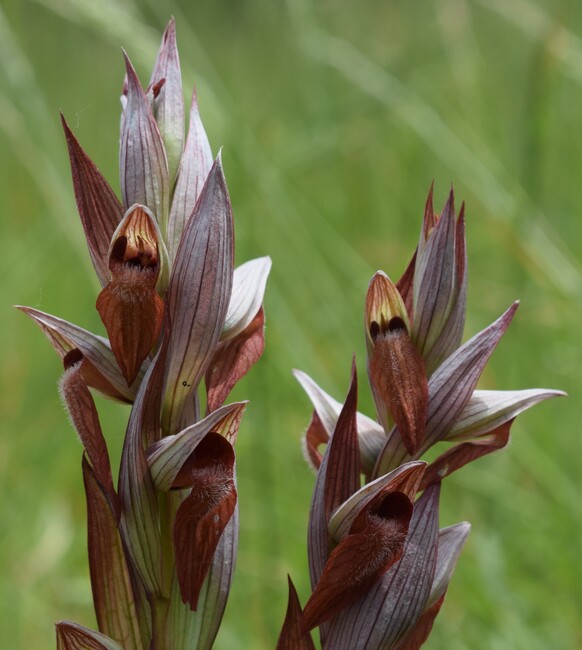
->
(220, 257), (271, 341)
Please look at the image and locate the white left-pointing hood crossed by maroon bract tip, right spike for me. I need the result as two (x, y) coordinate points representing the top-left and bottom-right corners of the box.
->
(293, 370), (386, 474)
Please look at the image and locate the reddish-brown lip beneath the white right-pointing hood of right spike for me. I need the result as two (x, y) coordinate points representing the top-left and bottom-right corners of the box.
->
(421, 420), (513, 489)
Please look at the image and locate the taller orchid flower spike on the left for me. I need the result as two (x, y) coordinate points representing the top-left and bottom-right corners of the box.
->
(21, 20), (271, 650)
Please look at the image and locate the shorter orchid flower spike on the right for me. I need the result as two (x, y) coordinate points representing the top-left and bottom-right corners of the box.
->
(277, 187), (563, 650)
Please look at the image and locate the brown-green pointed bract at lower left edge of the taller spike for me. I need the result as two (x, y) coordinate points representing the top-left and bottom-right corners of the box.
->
(83, 458), (144, 650)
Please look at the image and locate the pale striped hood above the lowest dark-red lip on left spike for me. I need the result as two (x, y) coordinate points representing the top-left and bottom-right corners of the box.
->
(147, 402), (247, 491)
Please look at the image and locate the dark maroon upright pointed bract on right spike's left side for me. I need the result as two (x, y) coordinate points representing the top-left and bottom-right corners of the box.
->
(307, 366), (360, 587)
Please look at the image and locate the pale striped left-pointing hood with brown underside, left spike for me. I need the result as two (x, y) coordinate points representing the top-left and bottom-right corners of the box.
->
(17, 306), (138, 402)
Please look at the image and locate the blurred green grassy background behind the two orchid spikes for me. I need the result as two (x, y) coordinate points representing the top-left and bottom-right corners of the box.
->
(0, 0), (582, 650)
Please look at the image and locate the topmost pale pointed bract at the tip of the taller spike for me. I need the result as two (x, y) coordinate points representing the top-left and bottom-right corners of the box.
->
(150, 18), (184, 187)
